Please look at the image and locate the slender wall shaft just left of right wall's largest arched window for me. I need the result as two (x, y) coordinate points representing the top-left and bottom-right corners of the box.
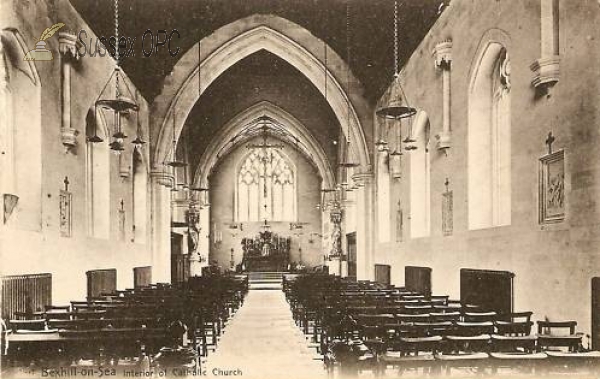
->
(433, 41), (452, 149)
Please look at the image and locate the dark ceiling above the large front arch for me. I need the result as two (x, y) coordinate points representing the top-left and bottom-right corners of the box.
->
(70, 0), (443, 102)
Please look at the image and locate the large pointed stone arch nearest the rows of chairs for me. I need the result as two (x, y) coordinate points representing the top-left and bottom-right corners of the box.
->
(151, 15), (372, 174)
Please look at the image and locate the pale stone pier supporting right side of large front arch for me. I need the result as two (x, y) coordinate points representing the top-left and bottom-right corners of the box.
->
(352, 171), (375, 280)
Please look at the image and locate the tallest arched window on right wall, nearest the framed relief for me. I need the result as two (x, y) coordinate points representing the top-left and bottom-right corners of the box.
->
(468, 42), (511, 229)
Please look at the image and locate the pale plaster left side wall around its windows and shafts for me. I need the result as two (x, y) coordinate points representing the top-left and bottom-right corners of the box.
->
(0, 0), (155, 304)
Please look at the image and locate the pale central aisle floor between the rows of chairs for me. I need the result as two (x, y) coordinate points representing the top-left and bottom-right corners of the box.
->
(205, 290), (327, 379)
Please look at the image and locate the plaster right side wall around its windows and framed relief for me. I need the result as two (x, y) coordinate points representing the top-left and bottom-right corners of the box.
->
(376, 0), (600, 336)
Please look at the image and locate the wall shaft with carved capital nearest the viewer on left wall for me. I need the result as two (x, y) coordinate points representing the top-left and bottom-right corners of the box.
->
(58, 32), (79, 152)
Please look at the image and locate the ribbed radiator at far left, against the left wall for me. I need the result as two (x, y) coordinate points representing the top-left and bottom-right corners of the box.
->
(1, 274), (52, 320)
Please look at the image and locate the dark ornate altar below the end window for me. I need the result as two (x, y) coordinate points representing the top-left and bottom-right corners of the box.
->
(242, 231), (291, 272)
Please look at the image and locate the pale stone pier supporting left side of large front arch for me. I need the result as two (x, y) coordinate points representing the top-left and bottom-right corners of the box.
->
(150, 170), (173, 283)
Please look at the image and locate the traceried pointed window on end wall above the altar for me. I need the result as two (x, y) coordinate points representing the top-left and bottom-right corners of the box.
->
(237, 149), (296, 222)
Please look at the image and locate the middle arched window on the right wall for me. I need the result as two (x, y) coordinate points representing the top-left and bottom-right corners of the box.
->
(410, 111), (431, 238)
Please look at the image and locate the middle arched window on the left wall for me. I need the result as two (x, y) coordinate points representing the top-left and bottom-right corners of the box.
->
(86, 109), (110, 239)
